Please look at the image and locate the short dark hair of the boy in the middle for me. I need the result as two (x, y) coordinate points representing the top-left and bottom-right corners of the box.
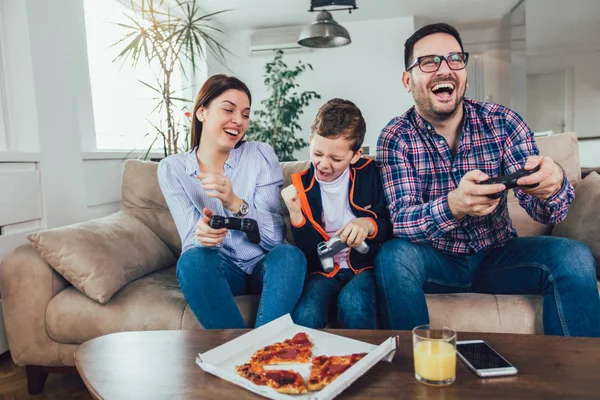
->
(312, 98), (367, 153)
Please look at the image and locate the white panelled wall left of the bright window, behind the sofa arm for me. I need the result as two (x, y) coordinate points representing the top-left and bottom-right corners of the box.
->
(0, 0), (123, 260)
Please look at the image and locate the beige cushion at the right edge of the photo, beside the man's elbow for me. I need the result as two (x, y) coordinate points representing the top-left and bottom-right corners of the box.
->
(552, 172), (600, 277)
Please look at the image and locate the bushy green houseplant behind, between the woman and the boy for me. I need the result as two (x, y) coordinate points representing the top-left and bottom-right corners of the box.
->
(246, 50), (321, 161)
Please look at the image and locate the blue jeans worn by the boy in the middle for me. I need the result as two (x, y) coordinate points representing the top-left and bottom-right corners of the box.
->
(292, 269), (377, 329)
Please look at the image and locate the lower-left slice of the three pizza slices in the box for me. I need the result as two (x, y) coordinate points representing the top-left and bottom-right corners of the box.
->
(235, 363), (306, 394)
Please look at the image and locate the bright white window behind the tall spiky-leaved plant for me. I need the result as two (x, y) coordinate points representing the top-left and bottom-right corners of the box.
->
(84, 0), (182, 150)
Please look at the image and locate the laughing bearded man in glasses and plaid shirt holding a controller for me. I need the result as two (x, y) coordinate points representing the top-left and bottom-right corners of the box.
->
(375, 24), (600, 336)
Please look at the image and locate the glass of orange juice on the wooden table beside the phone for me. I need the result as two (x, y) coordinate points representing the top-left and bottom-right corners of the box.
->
(413, 325), (456, 386)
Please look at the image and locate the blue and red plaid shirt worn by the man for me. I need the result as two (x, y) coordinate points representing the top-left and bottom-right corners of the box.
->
(377, 99), (574, 254)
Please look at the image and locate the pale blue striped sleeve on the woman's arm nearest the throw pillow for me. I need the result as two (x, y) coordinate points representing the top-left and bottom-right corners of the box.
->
(157, 158), (202, 247)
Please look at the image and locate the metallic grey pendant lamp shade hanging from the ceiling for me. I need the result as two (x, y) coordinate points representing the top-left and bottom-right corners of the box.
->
(298, 11), (351, 48)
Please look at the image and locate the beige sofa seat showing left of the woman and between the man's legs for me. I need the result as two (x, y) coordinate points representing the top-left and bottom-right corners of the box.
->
(46, 267), (543, 343)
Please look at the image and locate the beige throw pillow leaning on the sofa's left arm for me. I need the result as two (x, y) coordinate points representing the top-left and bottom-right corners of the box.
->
(28, 212), (176, 304)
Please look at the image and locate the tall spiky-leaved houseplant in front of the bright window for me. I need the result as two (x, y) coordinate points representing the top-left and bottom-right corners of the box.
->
(113, 0), (229, 158)
